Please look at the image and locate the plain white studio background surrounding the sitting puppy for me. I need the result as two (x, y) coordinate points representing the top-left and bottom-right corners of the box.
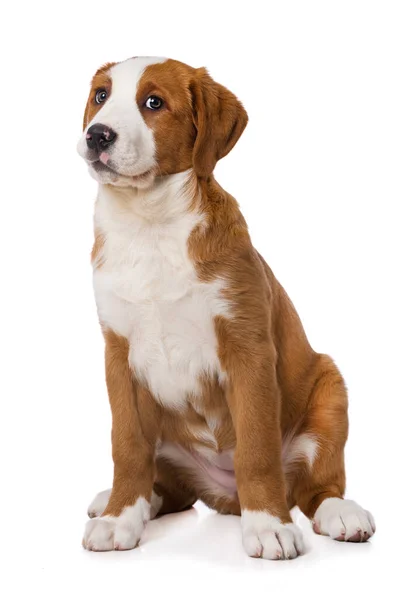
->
(0, 0), (400, 600)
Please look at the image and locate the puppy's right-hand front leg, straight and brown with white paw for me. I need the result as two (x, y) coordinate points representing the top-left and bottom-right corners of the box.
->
(222, 338), (303, 560)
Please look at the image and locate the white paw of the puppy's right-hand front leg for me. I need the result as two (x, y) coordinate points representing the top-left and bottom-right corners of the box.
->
(242, 510), (304, 560)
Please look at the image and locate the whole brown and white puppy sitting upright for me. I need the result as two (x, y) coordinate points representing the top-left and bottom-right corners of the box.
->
(78, 57), (375, 559)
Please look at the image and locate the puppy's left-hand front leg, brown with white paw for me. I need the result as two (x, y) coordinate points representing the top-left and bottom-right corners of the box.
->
(83, 331), (159, 551)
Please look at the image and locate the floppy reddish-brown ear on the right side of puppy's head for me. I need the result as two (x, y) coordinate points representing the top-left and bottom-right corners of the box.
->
(191, 68), (248, 177)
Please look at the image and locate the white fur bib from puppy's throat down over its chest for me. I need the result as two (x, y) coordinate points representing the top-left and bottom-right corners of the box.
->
(94, 175), (228, 409)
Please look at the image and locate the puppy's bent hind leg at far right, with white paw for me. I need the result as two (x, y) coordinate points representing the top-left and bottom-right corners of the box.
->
(288, 355), (375, 542)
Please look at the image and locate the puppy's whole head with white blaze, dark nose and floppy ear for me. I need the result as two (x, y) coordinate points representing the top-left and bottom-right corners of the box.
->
(78, 57), (247, 188)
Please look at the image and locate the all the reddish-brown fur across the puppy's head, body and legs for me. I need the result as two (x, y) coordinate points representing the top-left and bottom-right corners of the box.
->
(88, 61), (347, 522)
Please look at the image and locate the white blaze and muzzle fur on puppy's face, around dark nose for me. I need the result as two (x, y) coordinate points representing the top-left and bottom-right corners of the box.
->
(78, 57), (166, 185)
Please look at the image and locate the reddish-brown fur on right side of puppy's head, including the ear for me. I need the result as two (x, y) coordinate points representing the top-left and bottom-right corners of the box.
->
(136, 59), (247, 177)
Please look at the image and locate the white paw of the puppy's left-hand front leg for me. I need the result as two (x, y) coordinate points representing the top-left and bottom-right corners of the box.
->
(82, 497), (150, 552)
